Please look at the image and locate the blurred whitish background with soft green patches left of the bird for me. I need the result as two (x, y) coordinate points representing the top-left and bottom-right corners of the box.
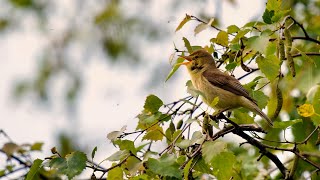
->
(0, 0), (316, 167)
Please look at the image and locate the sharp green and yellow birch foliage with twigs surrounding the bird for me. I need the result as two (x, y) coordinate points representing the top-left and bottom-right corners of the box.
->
(0, 0), (320, 180)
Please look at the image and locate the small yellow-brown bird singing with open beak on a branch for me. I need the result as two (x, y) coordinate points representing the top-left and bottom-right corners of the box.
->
(180, 49), (272, 126)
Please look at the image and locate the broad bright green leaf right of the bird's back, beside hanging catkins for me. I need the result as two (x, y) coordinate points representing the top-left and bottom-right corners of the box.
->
(256, 55), (280, 82)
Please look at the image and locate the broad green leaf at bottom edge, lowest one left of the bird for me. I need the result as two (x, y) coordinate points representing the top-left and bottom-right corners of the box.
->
(146, 154), (182, 179)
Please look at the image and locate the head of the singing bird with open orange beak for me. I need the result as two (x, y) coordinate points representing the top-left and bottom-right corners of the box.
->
(180, 49), (216, 72)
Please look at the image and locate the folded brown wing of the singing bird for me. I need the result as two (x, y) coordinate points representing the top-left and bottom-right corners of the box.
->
(203, 69), (255, 102)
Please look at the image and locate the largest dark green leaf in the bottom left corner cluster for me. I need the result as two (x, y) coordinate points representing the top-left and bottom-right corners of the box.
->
(50, 151), (87, 179)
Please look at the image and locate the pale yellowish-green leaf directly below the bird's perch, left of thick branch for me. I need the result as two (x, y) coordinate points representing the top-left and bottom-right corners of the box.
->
(202, 141), (227, 163)
